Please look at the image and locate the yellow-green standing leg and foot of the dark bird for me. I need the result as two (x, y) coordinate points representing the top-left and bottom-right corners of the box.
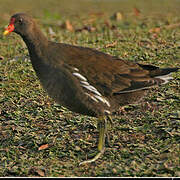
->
(79, 117), (107, 165)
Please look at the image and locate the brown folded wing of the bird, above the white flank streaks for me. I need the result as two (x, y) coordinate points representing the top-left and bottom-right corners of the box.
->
(47, 44), (166, 96)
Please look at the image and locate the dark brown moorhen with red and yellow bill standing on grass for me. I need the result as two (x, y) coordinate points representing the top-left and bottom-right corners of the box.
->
(3, 13), (179, 165)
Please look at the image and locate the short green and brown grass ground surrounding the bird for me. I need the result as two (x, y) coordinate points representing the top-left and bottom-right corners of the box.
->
(0, 0), (180, 177)
